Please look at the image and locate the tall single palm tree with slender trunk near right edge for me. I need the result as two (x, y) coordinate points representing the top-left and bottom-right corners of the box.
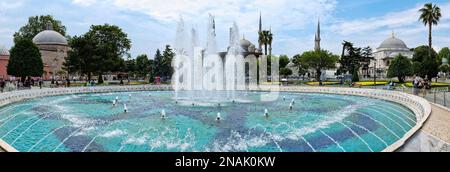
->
(419, 3), (442, 57)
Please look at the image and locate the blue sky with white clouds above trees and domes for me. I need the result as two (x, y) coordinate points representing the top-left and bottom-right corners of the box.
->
(0, 0), (450, 57)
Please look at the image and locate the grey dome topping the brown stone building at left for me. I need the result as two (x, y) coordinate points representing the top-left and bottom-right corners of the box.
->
(33, 23), (68, 45)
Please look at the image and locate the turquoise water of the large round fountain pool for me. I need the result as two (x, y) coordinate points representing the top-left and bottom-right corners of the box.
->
(0, 91), (416, 152)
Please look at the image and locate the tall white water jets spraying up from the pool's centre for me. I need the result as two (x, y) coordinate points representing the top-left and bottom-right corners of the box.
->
(172, 15), (250, 106)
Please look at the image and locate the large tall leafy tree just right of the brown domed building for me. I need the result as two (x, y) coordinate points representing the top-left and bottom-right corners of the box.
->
(85, 24), (131, 83)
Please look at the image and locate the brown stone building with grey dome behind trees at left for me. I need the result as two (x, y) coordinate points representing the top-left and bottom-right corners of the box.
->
(33, 23), (69, 80)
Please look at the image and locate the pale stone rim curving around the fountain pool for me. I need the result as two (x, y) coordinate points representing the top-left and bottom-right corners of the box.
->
(0, 85), (431, 152)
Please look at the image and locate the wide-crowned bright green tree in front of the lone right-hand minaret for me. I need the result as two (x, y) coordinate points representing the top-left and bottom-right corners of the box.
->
(299, 50), (339, 83)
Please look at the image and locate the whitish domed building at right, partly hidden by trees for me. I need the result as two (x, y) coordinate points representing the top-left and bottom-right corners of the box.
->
(369, 33), (413, 77)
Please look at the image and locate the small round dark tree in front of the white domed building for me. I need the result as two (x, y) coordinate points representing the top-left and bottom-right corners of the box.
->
(387, 54), (412, 83)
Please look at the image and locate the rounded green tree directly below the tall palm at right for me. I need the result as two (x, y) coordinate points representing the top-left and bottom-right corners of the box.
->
(412, 45), (440, 78)
